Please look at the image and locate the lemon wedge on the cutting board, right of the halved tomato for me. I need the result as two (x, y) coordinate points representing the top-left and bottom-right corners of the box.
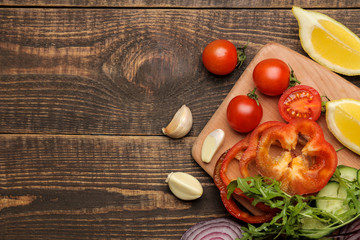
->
(326, 98), (360, 154)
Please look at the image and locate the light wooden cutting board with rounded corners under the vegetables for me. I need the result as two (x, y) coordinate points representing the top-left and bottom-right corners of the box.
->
(192, 43), (360, 182)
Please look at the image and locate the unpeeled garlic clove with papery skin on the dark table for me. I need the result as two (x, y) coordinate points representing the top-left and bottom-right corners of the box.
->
(162, 104), (193, 138)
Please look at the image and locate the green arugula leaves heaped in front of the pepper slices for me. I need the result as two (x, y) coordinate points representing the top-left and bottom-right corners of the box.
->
(228, 170), (360, 240)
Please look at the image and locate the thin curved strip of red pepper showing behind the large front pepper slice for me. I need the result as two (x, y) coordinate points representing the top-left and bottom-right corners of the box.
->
(239, 121), (285, 178)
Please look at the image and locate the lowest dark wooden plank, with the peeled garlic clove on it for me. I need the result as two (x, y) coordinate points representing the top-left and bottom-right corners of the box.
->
(0, 134), (228, 239)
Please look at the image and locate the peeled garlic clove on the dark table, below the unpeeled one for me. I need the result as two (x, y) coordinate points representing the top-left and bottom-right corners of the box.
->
(165, 172), (203, 200)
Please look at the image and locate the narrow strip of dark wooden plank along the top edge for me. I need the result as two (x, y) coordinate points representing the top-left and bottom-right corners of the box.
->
(0, 0), (360, 8)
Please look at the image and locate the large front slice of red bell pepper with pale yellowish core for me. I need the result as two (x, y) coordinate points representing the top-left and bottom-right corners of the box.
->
(256, 119), (337, 195)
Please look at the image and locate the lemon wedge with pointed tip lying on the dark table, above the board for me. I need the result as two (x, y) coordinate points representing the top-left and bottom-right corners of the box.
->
(292, 6), (360, 76)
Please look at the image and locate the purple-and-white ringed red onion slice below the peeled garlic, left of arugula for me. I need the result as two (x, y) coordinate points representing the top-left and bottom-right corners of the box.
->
(180, 218), (242, 240)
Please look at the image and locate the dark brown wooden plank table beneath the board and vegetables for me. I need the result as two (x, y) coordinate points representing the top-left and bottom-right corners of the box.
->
(0, 0), (360, 239)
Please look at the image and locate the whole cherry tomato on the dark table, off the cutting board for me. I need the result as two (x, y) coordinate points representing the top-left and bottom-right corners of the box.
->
(202, 39), (238, 75)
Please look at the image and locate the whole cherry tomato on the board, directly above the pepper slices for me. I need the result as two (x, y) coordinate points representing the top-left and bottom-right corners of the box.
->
(227, 95), (263, 133)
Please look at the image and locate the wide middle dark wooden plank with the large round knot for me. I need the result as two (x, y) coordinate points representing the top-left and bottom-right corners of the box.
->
(0, 8), (360, 136)
